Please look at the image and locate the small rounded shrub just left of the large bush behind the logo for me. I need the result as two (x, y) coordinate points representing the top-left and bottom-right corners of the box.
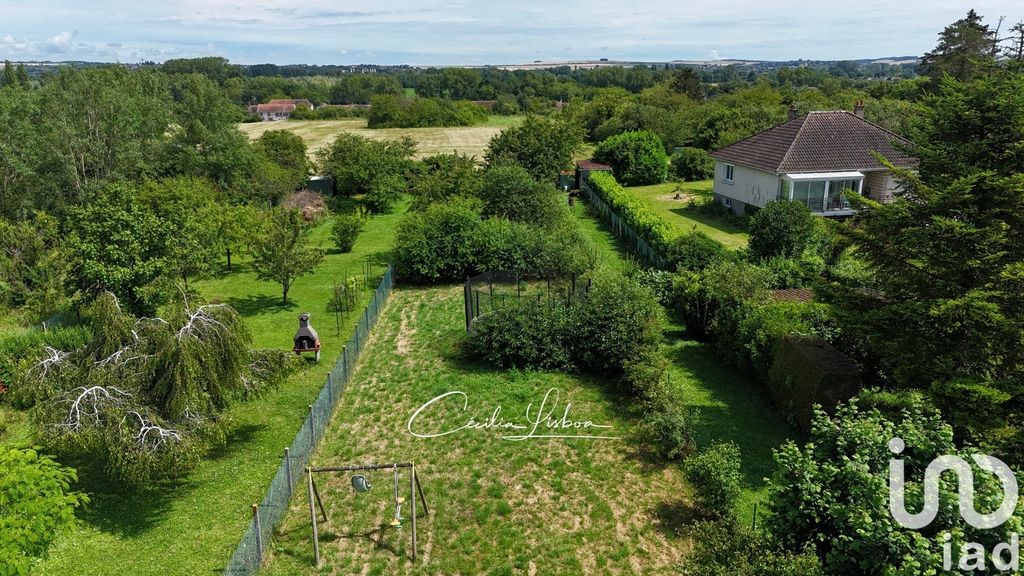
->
(685, 442), (743, 518)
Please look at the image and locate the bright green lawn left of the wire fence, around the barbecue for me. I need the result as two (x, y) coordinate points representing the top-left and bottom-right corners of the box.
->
(33, 195), (408, 576)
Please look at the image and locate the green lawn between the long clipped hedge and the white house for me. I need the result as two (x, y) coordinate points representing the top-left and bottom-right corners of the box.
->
(628, 180), (750, 248)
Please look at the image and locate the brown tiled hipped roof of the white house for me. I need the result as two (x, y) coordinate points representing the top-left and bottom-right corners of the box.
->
(711, 111), (918, 173)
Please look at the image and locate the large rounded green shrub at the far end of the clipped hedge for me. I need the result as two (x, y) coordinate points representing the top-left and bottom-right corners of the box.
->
(594, 130), (669, 186)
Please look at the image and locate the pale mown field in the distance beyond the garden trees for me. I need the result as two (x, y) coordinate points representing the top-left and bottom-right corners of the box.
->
(239, 116), (522, 160)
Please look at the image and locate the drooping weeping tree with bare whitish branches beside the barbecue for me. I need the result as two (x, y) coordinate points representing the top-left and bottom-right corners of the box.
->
(19, 293), (272, 486)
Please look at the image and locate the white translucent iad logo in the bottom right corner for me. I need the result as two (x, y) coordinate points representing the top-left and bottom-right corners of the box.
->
(889, 438), (1019, 571)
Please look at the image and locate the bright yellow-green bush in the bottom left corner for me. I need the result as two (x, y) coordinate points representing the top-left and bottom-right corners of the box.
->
(0, 446), (89, 576)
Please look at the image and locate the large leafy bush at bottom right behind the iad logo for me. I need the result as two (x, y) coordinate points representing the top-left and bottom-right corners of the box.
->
(766, 399), (1022, 574)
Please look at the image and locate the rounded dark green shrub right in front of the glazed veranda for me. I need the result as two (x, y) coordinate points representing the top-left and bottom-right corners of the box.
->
(750, 200), (816, 260)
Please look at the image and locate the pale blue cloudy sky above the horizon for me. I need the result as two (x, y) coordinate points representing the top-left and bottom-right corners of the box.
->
(0, 0), (1024, 66)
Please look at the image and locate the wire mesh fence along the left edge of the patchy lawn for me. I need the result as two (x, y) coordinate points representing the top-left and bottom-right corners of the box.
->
(224, 264), (394, 576)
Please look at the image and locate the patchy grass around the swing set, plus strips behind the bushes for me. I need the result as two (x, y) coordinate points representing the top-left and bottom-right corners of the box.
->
(264, 199), (790, 575)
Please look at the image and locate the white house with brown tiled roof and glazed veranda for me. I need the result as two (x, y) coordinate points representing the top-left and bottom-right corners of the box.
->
(711, 102), (918, 216)
